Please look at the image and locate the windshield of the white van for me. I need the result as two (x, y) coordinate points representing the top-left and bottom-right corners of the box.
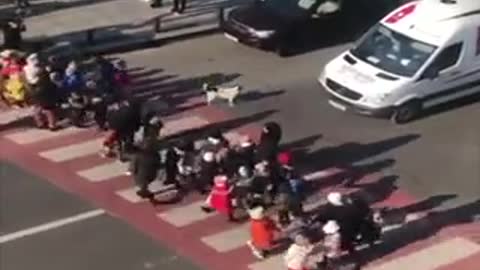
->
(351, 24), (437, 77)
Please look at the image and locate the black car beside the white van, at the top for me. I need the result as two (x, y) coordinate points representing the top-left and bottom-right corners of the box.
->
(222, 0), (343, 56)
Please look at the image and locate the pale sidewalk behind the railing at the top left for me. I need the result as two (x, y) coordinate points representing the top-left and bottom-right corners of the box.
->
(13, 0), (249, 53)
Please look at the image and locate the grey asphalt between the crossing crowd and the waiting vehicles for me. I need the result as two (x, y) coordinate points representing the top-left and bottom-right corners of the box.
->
(119, 30), (480, 206)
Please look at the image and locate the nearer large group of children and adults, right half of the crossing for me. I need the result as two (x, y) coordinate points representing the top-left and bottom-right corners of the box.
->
(115, 117), (372, 270)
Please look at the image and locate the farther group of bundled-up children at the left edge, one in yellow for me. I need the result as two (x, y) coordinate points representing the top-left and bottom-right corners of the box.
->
(0, 50), (130, 131)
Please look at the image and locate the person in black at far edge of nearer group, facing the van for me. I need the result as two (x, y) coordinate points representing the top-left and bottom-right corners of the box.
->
(257, 122), (282, 163)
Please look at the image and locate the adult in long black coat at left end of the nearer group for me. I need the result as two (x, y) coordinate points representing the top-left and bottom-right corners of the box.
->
(133, 140), (161, 198)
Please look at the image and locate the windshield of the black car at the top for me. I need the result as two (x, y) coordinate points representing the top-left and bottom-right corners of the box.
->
(263, 0), (319, 18)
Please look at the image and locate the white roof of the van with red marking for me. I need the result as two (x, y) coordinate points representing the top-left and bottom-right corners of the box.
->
(381, 0), (480, 45)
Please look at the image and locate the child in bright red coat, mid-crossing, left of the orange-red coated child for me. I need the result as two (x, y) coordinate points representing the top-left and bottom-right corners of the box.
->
(202, 174), (234, 221)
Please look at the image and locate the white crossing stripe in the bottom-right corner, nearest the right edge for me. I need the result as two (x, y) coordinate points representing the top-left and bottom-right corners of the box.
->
(369, 237), (480, 270)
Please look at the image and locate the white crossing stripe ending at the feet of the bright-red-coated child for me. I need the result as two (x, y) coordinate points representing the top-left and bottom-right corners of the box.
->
(157, 200), (217, 228)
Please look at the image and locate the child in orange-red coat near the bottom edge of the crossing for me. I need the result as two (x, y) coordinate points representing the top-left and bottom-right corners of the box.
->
(247, 206), (280, 259)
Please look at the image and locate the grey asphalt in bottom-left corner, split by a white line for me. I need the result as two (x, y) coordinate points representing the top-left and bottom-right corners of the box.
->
(0, 163), (200, 270)
